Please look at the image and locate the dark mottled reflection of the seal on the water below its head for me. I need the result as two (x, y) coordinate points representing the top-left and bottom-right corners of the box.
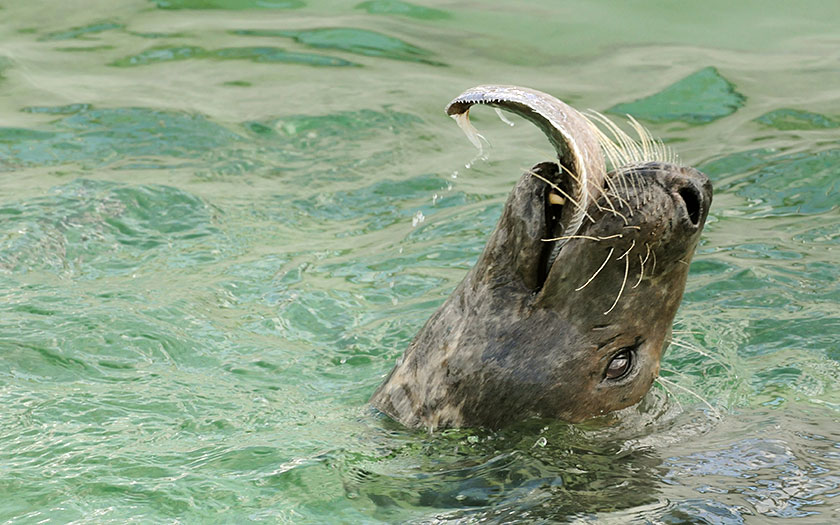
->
(342, 389), (684, 523)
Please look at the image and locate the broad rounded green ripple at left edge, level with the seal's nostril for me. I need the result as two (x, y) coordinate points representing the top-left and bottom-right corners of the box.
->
(0, 179), (223, 278)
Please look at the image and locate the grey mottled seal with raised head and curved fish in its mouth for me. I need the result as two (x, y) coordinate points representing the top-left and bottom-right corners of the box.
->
(371, 86), (712, 430)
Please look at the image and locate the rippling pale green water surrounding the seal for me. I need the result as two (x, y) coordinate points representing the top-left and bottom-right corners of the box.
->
(0, 0), (840, 524)
